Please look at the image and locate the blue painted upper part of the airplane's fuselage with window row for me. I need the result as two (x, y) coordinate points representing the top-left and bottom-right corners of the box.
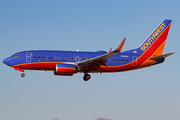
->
(3, 50), (140, 67)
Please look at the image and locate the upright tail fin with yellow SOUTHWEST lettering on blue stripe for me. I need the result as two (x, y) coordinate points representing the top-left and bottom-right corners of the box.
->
(137, 20), (172, 57)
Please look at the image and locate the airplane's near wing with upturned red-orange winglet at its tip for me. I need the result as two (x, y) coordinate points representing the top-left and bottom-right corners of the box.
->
(76, 38), (126, 71)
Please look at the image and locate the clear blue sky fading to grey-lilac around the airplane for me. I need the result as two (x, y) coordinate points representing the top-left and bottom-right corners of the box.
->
(0, 0), (180, 120)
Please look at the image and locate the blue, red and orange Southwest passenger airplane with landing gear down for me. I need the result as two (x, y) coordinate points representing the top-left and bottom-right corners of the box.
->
(3, 19), (174, 81)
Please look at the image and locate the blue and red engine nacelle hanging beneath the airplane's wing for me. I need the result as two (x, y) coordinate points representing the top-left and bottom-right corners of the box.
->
(54, 63), (77, 76)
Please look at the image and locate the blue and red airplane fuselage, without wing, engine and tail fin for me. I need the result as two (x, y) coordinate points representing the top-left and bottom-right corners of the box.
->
(3, 50), (158, 72)
